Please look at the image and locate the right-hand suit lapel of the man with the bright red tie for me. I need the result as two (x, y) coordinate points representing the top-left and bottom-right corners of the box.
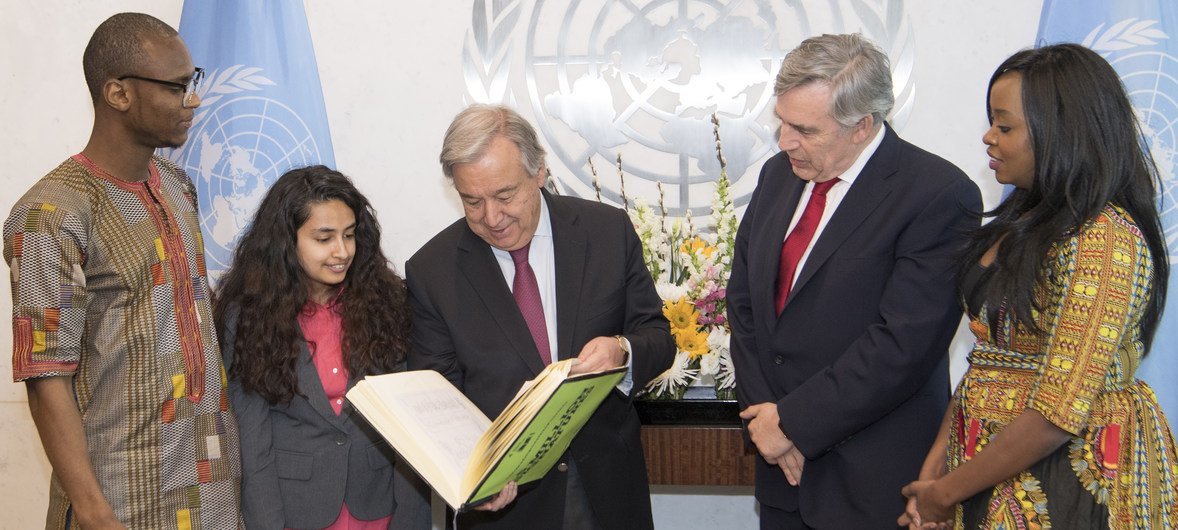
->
(782, 125), (900, 313)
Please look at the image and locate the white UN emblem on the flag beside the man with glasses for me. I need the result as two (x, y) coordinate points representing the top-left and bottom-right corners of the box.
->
(168, 65), (324, 280)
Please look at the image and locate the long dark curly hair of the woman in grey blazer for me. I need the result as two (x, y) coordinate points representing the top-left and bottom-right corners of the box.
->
(214, 166), (410, 404)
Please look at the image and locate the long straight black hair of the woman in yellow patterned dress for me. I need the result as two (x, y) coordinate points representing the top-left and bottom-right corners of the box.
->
(959, 44), (1170, 352)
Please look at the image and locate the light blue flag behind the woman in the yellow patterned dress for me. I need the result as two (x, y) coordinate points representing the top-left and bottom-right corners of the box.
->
(1039, 0), (1178, 421)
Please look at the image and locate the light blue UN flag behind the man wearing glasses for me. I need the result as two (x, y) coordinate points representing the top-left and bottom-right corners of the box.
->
(163, 0), (335, 280)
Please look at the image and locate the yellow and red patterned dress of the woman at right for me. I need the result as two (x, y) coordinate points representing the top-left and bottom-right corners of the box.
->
(948, 207), (1178, 530)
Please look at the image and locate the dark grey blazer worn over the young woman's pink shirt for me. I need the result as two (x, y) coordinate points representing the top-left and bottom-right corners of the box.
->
(221, 311), (429, 530)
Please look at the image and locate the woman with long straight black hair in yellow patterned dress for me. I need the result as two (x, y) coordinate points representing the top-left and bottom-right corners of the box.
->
(899, 45), (1178, 530)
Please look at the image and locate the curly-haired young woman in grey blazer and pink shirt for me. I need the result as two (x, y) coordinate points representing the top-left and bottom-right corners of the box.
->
(216, 166), (428, 530)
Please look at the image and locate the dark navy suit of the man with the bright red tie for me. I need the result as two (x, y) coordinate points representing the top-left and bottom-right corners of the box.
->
(728, 127), (981, 529)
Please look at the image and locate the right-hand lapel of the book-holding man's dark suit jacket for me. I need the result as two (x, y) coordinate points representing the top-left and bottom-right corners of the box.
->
(544, 192), (585, 359)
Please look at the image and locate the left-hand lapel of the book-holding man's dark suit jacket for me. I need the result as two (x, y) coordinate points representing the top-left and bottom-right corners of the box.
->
(458, 227), (544, 375)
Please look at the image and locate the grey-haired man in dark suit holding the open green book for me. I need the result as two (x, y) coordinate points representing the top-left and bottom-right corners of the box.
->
(405, 105), (675, 530)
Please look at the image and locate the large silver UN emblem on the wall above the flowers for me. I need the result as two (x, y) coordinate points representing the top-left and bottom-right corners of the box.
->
(463, 0), (915, 216)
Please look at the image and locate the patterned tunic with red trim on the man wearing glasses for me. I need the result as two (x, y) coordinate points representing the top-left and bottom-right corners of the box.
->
(4, 154), (240, 529)
